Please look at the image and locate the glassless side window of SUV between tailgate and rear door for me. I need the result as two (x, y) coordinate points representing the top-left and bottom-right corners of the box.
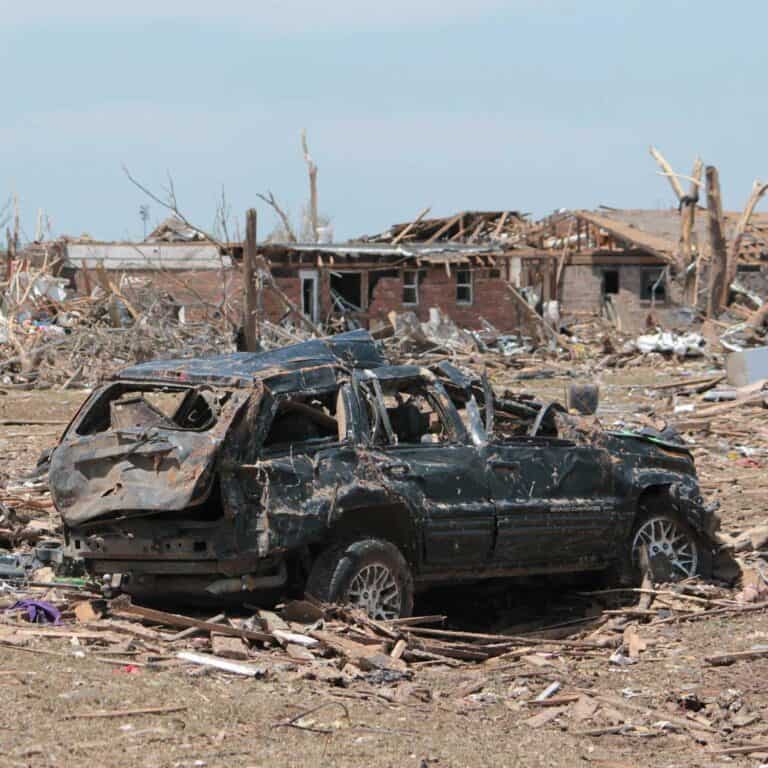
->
(262, 390), (343, 451)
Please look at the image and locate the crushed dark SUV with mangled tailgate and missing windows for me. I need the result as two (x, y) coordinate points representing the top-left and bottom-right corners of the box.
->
(49, 331), (718, 619)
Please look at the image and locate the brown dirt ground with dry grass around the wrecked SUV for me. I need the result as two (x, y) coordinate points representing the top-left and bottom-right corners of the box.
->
(0, 363), (768, 768)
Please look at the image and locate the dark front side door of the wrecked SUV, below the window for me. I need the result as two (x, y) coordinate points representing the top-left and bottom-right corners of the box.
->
(486, 437), (617, 570)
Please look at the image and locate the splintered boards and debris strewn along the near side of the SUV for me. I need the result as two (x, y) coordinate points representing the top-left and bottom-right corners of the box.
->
(0, 560), (768, 755)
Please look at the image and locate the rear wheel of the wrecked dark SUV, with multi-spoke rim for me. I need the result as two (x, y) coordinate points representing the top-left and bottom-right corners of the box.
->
(305, 539), (413, 620)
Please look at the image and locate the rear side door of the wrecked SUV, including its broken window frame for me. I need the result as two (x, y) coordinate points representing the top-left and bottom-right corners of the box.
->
(356, 368), (495, 574)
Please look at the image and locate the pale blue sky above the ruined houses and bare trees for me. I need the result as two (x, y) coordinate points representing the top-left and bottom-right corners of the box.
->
(0, 0), (768, 239)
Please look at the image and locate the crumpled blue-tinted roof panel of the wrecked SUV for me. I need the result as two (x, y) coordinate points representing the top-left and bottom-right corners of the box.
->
(115, 330), (387, 385)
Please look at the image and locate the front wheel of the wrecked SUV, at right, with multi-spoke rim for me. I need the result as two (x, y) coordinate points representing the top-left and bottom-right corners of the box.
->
(631, 513), (712, 581)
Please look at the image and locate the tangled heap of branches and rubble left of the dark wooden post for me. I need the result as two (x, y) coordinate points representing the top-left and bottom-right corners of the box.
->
(0, 260), (240, 389)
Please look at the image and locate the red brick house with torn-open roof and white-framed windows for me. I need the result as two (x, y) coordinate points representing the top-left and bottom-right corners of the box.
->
(252, 211), (553, 331)
